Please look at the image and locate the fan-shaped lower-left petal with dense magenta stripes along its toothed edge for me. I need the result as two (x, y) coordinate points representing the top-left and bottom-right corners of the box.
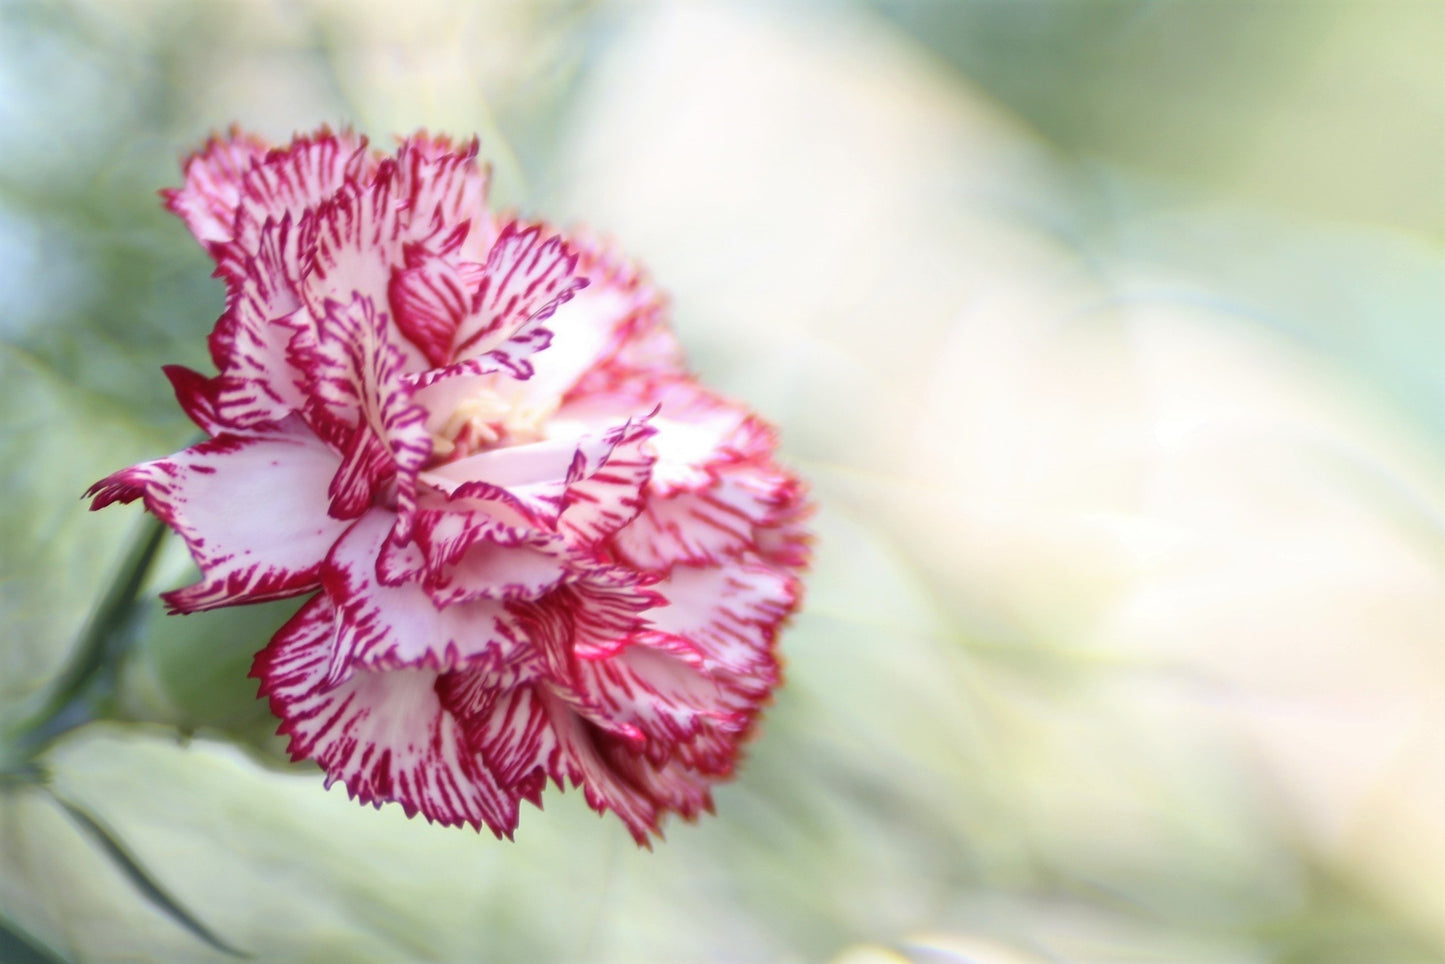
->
(251, 595), (517, 837)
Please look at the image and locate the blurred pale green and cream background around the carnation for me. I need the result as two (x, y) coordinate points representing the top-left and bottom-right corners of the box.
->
(0, 0), (1445, 964)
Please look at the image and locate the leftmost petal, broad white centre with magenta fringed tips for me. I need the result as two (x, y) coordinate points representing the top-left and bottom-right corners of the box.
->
(90, 418), (345, 613)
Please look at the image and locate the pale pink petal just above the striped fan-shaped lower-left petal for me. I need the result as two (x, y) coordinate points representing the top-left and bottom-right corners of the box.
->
(321, 509), (537, 684)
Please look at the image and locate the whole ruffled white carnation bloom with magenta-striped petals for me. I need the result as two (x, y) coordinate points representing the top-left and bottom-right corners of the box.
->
(91, 130), (808, 844)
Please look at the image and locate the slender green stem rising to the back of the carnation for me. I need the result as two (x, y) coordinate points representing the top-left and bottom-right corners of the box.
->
(7, 516), (166, 769)
